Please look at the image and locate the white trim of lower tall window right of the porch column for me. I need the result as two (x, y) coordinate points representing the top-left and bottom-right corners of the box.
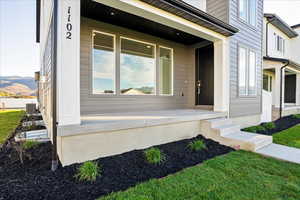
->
(237, 44), (257, 98)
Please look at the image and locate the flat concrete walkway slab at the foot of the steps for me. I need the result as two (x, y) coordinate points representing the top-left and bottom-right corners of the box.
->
(255, 144), (300, 164)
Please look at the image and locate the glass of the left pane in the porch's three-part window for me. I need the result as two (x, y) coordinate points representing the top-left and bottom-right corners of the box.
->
(93, 32), (115, 94)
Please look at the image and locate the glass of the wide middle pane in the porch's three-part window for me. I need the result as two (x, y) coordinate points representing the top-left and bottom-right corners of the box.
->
(120, 38), (156, 95)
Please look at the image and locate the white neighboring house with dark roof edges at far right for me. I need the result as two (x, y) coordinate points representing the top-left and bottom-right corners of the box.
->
(263, 14), (300, 119)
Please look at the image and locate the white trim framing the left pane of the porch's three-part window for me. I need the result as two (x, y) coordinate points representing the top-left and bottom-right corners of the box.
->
(91, 30), (117, 96)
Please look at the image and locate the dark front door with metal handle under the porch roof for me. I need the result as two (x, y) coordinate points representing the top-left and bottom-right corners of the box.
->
(195, 44), (214, 105)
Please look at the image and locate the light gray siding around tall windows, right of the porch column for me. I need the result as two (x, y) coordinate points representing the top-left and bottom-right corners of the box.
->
(229, 0), (263, 117)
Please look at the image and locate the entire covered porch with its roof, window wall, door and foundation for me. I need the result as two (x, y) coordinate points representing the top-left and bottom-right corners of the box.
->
(57, 0), (238, 165)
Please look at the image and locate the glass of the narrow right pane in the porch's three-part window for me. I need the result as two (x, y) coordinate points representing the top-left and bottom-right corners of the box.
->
(159, 47), (173, 95)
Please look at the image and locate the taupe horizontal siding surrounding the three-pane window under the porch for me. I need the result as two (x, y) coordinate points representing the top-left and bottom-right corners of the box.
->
(80, 18), (195, 114)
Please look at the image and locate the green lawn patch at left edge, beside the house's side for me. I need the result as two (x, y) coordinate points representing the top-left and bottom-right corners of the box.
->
(0, 110), (24, 145)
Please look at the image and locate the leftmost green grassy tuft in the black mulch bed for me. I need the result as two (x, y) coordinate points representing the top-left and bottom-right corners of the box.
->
(75, 161), (101, 182)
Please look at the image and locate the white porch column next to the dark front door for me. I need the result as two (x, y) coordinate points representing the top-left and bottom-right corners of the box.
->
(214, 39), (230, 112)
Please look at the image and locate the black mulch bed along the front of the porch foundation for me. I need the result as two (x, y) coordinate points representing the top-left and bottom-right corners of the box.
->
(0, 136), (234, 200)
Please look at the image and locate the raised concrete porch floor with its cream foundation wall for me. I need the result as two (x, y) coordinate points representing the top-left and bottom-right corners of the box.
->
(57, 109), (227, 166)
